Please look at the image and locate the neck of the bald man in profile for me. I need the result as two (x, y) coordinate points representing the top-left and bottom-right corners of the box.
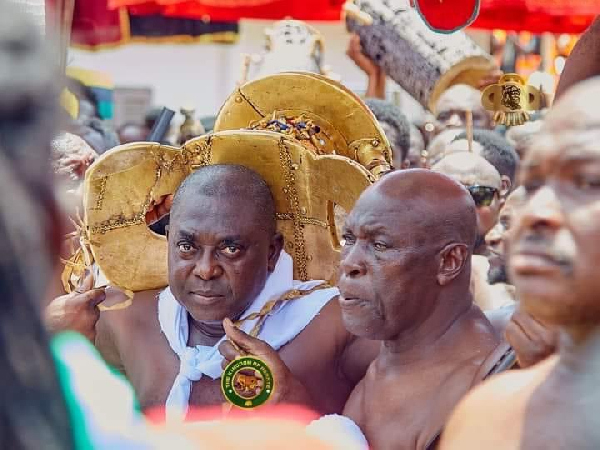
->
(377, 291), (473, 367)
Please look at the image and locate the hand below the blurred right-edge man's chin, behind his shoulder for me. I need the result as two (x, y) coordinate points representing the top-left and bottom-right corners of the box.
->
(504, 309), (558, 368)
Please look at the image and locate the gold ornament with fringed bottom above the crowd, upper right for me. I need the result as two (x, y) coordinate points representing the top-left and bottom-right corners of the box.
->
(481, 73), (542, 127)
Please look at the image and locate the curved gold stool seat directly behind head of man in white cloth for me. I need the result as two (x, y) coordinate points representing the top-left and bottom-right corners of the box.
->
(77, 130), (374, 291)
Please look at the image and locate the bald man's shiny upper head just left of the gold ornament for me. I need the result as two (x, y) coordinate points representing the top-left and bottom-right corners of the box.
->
(436, 86), (492, 132)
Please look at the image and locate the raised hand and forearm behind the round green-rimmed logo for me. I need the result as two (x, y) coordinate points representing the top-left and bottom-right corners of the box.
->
(219, 319), (310, 404)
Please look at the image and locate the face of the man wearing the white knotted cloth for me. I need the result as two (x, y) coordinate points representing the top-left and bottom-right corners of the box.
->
(168, 195), (281, 321)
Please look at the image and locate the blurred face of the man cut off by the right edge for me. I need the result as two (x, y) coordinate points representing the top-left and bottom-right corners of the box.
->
(508, 125), (600, 326)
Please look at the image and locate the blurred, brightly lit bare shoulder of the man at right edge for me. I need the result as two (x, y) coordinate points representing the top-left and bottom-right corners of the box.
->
(440, 357), (557, 450)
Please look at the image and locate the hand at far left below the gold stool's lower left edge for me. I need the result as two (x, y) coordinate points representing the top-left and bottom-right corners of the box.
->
(44, 273), (106, 342)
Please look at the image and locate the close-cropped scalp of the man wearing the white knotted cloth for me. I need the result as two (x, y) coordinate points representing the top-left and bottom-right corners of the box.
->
(171, 164), (276, 234)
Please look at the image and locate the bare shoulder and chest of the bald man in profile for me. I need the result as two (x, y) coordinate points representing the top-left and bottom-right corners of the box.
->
(344, 307), (498, 450)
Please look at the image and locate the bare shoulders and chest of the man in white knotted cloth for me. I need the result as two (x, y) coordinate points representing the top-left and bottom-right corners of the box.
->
(96, 289), (379, 413)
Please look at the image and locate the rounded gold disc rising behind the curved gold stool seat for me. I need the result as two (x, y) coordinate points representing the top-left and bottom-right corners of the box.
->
(215, 72), (392, 174)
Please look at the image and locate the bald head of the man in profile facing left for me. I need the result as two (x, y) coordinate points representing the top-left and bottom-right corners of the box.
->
(338, 169), (477, 340)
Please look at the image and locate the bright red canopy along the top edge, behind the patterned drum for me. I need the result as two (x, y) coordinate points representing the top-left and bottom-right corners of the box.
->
(109, 0), (600, 33)
